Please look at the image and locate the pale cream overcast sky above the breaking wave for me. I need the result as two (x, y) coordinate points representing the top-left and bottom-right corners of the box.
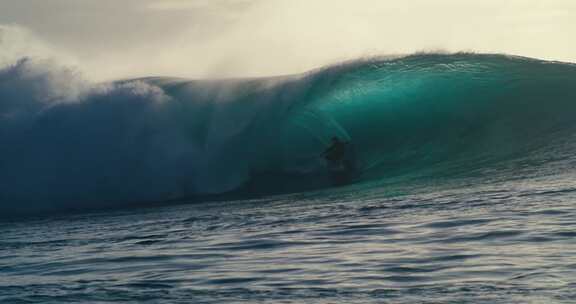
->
(0, 0), (576, 80)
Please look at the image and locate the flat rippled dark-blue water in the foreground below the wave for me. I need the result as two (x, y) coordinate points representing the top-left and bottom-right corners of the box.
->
(0, 178), (576, 303)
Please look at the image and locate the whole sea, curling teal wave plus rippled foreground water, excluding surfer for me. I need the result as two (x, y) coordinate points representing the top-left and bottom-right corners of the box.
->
(0, 53), (576, 303)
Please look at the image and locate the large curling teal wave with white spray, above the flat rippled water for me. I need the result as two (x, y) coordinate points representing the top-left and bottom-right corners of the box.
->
(0, 54), (576, 214)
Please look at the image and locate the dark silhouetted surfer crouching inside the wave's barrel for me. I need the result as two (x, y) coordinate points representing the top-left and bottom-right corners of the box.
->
(322, 136), (354, 185)
